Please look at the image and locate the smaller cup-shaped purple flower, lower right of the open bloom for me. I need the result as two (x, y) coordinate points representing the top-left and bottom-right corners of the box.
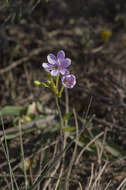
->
(61, 75), (76, 88)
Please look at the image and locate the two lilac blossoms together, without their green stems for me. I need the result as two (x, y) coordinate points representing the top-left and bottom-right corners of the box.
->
(42, 50), (76, 88)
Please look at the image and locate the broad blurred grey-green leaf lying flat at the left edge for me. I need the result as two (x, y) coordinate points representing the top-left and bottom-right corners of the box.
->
(0, 106), (26, 116)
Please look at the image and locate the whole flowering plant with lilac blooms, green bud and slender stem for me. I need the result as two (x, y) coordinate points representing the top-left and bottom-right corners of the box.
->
(35, 50), (76, 148)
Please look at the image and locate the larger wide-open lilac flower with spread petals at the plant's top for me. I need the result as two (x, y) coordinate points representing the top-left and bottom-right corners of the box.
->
(42, 50), (71, 76)
